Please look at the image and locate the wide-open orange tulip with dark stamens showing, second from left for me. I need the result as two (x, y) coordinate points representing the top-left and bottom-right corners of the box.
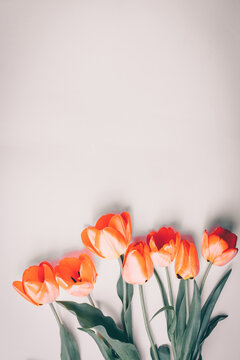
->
(54, 254), (97, 297)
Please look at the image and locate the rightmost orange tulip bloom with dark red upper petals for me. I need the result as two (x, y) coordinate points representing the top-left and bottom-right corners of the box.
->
(201, 227), (238, 266)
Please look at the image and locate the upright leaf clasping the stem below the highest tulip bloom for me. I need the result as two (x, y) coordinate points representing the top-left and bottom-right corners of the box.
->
(117, 273), (133, 342)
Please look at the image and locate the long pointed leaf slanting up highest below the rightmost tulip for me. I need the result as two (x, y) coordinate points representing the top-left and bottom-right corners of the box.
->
(193, 269), (232, 358)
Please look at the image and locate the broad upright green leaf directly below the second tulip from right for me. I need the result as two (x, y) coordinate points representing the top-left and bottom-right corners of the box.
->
(181, 280), (201, 360)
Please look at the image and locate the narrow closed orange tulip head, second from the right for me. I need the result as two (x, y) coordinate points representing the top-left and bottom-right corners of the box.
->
(175, 240), (199, 280)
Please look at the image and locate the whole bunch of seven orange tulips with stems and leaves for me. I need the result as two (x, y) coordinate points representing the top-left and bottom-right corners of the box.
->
(13, 212), (238, 360)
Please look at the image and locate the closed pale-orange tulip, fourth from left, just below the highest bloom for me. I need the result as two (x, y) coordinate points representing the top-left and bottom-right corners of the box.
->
(122, 241), (153, 284)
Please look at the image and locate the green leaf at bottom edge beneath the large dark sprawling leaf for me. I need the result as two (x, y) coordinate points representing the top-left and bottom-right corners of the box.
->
(80, 325), (140, 360)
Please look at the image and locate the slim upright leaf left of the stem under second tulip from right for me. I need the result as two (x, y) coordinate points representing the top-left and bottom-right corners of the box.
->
(176, 279), (186, 353)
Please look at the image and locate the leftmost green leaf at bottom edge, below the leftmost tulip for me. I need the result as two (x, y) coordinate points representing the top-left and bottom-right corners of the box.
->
(60, 325), (80, 360)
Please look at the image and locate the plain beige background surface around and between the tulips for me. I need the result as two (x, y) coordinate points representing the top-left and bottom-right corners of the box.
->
(0, 0), (240, 360)
